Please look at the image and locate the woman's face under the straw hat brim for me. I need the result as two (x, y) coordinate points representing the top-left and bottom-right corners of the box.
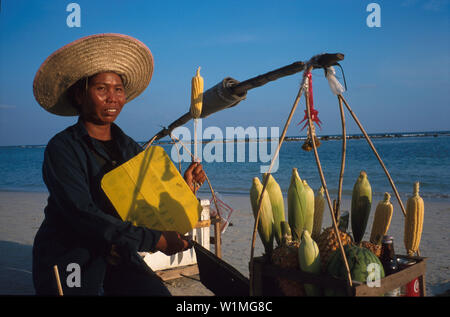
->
(80, 73), (126, 125)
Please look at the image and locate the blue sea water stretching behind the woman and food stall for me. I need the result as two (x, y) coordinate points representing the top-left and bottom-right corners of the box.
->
(0, 132), (450, 202)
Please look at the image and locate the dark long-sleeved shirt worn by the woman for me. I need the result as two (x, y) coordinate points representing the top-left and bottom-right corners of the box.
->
(33, 120), (161, 289)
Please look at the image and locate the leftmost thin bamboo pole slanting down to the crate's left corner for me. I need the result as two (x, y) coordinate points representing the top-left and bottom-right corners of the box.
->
(249, 66), (312, 296)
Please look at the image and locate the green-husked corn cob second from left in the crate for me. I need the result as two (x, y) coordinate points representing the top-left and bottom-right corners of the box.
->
(263, 173), (286, 245)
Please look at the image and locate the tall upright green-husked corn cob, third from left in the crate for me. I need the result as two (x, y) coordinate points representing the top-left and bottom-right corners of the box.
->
(288, 168), (306, 241)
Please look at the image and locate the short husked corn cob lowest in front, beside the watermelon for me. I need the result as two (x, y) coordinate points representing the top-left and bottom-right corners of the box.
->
(298, 230), (321, 296)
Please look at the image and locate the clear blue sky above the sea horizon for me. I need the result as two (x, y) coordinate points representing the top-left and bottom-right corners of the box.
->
(0, 0), (450, 145)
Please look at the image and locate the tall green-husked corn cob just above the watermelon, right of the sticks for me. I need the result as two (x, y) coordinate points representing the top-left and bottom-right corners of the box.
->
(350, 171), (372, 244)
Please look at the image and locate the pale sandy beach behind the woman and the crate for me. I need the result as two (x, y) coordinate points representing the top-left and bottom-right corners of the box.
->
(0, 192), (450, 296)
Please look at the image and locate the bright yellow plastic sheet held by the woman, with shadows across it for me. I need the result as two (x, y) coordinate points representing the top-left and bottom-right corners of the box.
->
(101, 146), (202, 234)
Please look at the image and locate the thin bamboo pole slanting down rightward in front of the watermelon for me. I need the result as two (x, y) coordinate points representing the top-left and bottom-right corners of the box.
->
(305, 73), (353, 287)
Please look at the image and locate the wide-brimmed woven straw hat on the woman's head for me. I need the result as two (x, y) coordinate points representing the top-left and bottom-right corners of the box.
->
(33, 33), (153, 116)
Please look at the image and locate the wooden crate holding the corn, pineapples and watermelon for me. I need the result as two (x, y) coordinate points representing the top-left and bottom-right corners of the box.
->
(251, 256), (426, 296)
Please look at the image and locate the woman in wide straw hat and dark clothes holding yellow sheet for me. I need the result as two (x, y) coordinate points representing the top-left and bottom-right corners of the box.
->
(33, 34), (206, 296)
